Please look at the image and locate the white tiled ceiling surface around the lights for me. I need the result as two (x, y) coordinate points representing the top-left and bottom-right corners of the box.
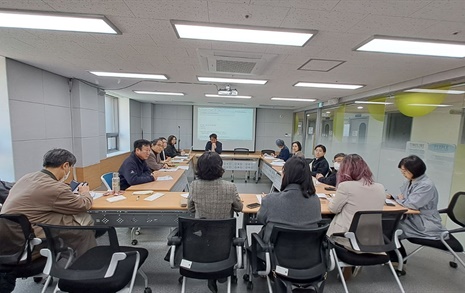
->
(0, 0), (465, 110)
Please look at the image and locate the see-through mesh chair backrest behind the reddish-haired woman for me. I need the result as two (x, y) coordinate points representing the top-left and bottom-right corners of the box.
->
(349, 210), (407, 252)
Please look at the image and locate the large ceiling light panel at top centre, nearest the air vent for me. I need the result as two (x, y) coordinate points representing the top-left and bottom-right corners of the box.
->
(172, 21), (316, 46)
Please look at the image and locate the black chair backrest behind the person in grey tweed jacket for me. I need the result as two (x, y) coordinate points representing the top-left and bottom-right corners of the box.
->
(179, 217), (236, 263)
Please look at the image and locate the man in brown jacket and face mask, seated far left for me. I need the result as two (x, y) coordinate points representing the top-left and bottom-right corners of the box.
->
(1, 149), (96, 258)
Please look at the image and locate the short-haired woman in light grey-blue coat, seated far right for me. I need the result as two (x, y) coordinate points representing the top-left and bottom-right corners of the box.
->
(387, 155), (446, 260)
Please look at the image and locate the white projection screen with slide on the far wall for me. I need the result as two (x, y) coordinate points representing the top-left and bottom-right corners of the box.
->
(193, 106), (256, 151)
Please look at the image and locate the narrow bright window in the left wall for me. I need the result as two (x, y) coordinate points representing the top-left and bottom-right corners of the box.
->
(105, 95), (119, 153)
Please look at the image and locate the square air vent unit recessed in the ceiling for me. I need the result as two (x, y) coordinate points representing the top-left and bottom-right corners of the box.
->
(198, 49), (278, 75)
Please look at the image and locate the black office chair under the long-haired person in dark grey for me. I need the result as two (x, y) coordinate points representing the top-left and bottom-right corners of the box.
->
(244, 224), (332, 293)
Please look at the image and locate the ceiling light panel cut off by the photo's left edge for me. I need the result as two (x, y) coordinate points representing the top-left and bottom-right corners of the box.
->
(0, 9), (121, 34)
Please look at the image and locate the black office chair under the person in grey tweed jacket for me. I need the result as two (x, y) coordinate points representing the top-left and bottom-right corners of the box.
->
(168, 217), (246, 293)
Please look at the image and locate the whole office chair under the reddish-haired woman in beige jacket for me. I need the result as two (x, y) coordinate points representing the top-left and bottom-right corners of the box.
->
(331, 210), (406, 292)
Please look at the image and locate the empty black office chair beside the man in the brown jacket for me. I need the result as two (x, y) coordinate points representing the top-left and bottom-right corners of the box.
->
(39, 224), (152, 293)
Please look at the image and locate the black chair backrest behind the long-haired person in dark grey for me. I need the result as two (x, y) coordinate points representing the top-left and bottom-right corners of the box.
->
(270, 224), (329, 279)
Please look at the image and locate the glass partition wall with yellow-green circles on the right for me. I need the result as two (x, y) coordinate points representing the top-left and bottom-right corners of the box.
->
(292, 84), (465, 236)
